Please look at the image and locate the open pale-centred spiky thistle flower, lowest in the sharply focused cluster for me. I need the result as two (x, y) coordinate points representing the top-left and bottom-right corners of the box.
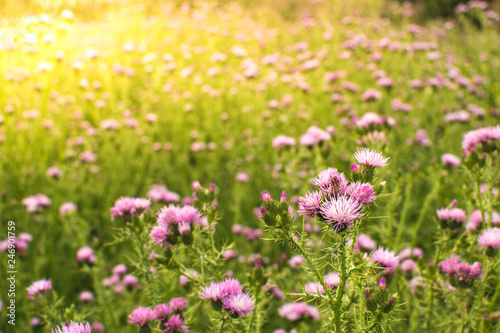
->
(321, 196), (364, 232)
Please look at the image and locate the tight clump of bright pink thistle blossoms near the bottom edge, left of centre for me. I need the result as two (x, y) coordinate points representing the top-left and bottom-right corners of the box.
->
(200, 279), (255, 318)
